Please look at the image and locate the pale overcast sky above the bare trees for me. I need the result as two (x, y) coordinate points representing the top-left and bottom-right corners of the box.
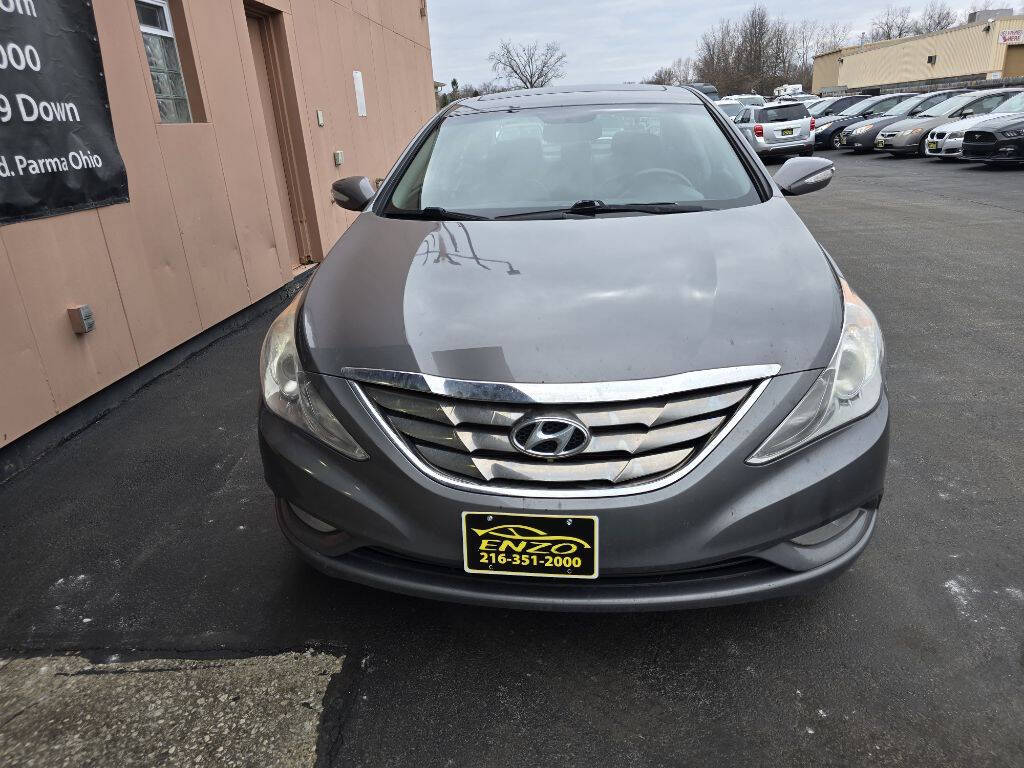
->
(428, 0), (974, 84)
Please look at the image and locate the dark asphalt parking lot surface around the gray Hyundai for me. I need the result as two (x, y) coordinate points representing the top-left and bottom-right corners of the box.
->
(0, 155), (1024, 766)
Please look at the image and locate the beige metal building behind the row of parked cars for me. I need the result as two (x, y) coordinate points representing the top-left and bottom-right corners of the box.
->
(812, 15), (1024, 93)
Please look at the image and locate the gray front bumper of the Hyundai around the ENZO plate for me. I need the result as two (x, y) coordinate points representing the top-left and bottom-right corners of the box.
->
(259, 371), (889, 610)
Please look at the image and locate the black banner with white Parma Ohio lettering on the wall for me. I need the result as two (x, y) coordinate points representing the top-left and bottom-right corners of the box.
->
(0, 0), (129, 224)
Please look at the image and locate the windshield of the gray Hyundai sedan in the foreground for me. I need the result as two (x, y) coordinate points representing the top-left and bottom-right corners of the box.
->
(383, 104), (761, 217)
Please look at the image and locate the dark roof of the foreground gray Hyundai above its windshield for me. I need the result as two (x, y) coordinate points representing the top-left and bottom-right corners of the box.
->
(451, 84), (701, 115)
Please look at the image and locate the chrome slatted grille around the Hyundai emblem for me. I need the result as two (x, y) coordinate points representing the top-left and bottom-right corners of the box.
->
(352, 367), (777, 495)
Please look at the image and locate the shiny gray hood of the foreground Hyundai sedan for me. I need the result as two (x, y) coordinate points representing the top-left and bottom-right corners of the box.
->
(300, 197), (842, 383)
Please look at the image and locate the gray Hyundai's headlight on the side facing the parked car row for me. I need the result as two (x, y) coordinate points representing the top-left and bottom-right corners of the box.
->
(746, 281), (885, 464)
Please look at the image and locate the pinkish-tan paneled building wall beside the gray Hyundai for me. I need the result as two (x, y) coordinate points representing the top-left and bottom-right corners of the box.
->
(0, 0), (434, 446)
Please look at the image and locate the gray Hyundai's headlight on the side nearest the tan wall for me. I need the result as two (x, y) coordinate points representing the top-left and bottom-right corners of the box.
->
(259, 294), (369, 461)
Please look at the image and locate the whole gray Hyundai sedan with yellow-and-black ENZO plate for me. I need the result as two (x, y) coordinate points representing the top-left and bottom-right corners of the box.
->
(259, 86), (889, 610)
